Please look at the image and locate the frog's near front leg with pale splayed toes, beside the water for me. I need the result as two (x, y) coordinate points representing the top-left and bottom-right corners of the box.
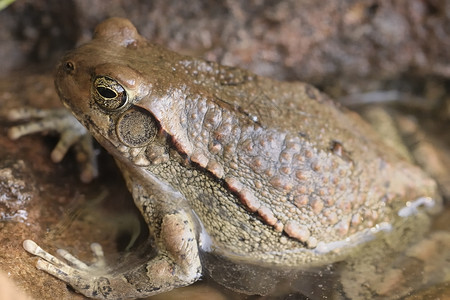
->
(24, 211), (201, 299)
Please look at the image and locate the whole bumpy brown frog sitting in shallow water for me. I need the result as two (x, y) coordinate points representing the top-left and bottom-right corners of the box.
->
(6, 18), (442, 299)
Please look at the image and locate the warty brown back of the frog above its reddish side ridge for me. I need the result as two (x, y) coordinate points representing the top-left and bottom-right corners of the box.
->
(138, 58), (436, 256)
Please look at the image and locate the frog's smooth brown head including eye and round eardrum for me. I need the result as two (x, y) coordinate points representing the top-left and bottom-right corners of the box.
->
(55, 18), (185, 164)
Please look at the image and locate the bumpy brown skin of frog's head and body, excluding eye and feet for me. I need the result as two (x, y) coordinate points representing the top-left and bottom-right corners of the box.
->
(44, 18), (438, 294)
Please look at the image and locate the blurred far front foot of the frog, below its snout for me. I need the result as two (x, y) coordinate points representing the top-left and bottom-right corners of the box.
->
(5, 107), (98, 182)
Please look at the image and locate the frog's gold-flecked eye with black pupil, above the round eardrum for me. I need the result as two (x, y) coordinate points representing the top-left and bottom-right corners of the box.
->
(92, 76), (128, 111)
